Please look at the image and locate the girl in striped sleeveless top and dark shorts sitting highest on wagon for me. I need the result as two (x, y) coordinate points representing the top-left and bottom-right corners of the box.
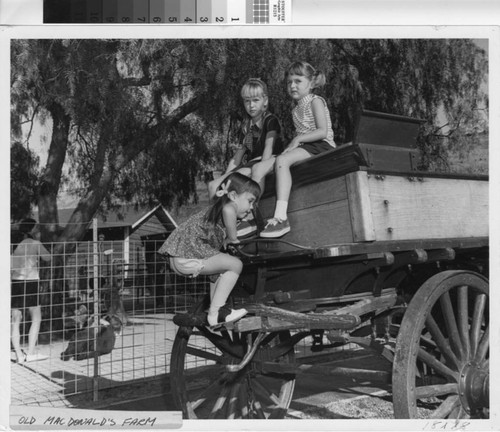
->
(260, 62), (335, 238)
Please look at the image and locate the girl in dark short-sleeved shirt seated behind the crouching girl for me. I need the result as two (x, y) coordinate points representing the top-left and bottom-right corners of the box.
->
(208, 78), (283, 236)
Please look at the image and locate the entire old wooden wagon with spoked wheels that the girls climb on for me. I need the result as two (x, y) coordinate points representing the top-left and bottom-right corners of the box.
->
(170, 112), (489, 418)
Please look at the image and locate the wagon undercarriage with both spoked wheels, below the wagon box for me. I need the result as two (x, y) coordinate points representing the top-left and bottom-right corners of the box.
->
(172, 239), (489, 418)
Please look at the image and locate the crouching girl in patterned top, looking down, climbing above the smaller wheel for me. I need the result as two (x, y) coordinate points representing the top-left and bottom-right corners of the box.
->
(158, 173), (260, 326)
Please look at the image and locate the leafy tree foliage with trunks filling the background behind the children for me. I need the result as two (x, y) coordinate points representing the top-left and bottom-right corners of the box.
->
(11, 39), (487, 246)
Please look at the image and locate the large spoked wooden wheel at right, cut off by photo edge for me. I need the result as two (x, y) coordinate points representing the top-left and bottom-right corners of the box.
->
(392, 271), (489, 419)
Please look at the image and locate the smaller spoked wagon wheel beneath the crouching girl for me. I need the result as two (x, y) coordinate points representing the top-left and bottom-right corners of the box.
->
(170, 296), (295, 419)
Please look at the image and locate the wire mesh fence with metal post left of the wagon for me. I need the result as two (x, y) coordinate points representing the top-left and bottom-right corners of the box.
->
(11, 231), (209, 406)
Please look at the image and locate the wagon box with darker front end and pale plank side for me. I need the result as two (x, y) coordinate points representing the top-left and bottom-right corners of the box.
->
(259, 146), (488, 252)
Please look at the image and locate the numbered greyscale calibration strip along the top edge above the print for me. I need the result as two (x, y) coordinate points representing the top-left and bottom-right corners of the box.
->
(43, 0), (292, 25)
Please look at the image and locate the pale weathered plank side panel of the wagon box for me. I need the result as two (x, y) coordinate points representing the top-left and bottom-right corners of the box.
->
(347, 171), (488, 241)
